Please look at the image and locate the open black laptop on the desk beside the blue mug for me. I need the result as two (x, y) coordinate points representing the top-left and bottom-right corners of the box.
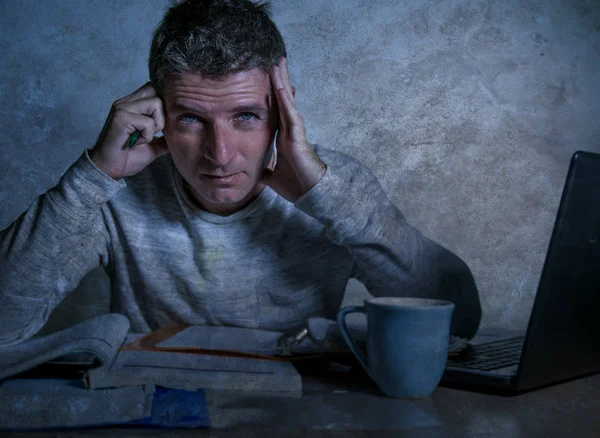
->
(441, 151), (600, 395)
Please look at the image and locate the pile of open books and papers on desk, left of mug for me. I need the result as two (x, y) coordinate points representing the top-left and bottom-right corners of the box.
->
(0, 313), (364, 430)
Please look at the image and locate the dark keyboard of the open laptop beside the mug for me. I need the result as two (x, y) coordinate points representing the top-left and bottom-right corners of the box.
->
(447, 336), (525, 371)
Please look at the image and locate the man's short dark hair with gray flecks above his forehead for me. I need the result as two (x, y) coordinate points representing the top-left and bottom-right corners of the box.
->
(148, 0), (286, 97)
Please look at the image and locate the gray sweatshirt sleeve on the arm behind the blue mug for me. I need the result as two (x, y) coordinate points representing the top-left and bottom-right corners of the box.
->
(294, 146), (481, 339)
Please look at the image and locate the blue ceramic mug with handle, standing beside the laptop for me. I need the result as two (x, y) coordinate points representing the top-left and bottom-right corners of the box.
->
(337, 297), (454, 398)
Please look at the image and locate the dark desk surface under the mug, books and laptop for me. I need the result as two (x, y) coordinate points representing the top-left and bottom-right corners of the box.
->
(2, 362), (600, 438)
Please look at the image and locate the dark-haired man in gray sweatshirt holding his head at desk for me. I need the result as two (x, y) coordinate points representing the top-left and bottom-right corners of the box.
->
(0, 0), (481, 345)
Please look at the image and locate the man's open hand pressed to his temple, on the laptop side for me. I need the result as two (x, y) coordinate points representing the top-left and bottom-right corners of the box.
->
(261, 58), (327, 202)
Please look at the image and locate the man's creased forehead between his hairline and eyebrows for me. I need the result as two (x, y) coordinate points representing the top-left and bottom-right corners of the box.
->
(163, 69), (271, 111)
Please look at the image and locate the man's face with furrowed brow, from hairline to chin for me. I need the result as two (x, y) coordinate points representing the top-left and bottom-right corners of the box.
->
(163, 69), (278, 215)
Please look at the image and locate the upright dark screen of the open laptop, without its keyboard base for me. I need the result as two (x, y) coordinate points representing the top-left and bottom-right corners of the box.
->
(518, 152), (600, 389)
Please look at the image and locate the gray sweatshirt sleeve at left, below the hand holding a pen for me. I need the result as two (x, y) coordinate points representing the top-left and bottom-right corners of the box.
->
(0, 150), (126, 346)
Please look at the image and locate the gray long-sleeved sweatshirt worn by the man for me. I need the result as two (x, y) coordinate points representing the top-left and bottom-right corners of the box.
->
(0, 145), (481, 345)
